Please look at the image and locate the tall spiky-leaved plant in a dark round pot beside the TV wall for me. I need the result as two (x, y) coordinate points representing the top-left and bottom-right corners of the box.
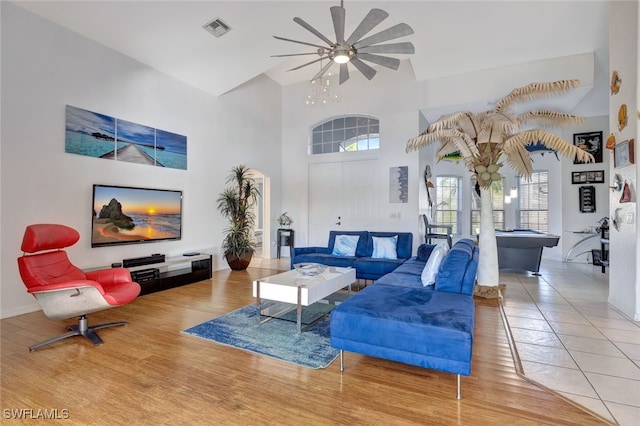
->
(217, 165), (260, 271)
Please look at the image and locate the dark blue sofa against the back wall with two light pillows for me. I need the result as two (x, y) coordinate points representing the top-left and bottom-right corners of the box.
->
(291, 231), (413, 280)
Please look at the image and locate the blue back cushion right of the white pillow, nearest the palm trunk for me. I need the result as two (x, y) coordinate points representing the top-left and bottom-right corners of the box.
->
(435, 239), (478, 294)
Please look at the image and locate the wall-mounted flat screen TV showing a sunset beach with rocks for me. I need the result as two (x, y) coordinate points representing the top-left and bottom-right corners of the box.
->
(91, 185), (182, 247)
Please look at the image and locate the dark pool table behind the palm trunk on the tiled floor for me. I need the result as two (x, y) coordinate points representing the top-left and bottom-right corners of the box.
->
(496, 229), (560, 275)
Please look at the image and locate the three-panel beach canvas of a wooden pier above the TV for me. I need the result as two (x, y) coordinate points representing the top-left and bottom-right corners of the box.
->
(65, 105), (187, 170)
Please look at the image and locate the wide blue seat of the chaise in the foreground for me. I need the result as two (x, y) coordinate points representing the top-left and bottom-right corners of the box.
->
(331, 284), (475, 375)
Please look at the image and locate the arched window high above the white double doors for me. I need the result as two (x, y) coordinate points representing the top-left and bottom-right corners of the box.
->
(309, 115), (380, 154)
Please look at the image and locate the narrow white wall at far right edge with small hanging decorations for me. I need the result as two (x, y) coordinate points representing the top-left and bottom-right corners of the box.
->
(609, 1), (640, 321)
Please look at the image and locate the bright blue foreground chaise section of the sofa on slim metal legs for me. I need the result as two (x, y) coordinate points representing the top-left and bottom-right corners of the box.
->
(331, 239), (478, 399)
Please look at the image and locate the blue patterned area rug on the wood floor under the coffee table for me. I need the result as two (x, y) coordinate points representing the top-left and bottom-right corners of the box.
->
(183, 304), (340, 368)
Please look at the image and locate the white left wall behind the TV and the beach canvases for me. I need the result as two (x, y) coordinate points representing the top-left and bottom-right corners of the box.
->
(0, 2), (282, 317)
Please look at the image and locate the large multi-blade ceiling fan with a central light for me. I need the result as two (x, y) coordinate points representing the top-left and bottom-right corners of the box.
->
(272, 1), (415, 84)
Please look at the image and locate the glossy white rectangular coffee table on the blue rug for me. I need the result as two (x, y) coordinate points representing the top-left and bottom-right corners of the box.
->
(253, 266), (356, 333)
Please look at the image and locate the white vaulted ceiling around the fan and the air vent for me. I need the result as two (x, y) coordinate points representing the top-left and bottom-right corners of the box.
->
(15, 0), (609, 96)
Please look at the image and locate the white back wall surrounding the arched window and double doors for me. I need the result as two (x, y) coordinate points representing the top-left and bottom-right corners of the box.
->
(274, 61), (419, 249)
